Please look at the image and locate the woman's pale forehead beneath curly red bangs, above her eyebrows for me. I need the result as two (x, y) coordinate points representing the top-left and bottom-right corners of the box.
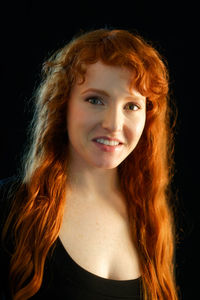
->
(77, 61), (143, 97)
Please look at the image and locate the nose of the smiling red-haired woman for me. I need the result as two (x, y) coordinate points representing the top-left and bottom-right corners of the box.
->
(102, 107), (123, 132)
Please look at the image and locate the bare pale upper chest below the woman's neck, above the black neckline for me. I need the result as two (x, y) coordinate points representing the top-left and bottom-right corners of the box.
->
(59, 196), (140, 280)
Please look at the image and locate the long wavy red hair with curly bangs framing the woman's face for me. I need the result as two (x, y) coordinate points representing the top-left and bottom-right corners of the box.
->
(3, 29), (178, 300)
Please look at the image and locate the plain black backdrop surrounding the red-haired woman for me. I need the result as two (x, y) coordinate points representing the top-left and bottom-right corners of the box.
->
(0, 0), (200, 299)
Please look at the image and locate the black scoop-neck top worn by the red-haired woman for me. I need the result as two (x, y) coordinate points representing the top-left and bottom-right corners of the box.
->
(0, 180), (142, 300)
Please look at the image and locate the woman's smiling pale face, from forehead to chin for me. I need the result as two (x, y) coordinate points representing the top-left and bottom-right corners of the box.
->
(67, 62), (146, 169)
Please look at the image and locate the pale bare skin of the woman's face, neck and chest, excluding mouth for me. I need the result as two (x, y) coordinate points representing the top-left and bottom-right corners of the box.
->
(59, 62), (146, 280)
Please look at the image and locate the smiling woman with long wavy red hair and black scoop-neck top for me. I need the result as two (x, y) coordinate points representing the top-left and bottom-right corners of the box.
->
(2, 29), (177, 300)
